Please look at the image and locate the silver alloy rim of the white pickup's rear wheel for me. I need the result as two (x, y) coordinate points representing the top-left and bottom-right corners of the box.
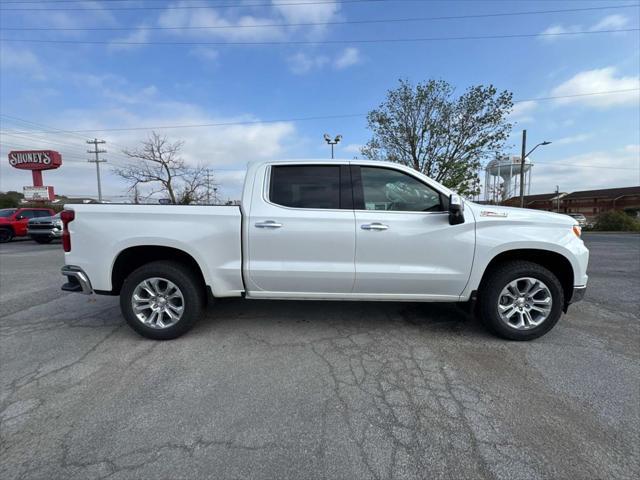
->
(131, 277), (184, 329)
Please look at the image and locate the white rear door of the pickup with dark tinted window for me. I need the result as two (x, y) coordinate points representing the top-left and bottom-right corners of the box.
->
(247, 164), (355, 296)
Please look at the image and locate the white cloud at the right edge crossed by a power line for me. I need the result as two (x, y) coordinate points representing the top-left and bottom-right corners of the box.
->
(551, 67), (640, 108)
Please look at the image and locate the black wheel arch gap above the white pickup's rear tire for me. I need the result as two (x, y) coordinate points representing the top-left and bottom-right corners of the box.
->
(110, 245), (207, 295)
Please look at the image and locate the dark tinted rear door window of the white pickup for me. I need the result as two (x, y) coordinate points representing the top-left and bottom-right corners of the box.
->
(269, 165), (341, 209)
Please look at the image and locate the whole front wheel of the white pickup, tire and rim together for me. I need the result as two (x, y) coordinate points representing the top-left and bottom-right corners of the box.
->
(479, 261), (564, 340)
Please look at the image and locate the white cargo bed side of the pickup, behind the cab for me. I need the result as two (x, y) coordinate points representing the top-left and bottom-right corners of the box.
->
(65, 204), (244, 296)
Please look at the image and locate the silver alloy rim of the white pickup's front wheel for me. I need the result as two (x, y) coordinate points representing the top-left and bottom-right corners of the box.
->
(498, 277), (553, 330)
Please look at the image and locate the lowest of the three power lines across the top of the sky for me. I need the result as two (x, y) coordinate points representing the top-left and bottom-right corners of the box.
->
(0, 28), (640, 47)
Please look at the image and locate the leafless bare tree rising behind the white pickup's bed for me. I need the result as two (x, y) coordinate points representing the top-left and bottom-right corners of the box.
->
(114, 132), (207, 204)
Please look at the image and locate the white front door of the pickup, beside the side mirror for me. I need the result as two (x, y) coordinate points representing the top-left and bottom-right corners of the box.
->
(353, 166), (475, 300)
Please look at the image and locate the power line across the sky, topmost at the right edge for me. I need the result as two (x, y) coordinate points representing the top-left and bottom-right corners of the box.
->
(2, 4), (640, 32)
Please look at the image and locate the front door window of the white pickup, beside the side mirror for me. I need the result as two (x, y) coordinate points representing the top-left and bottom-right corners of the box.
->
(360, 167), (442, 212)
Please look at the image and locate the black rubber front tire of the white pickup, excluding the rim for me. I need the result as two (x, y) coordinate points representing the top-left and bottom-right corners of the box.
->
(478, 261), (564, 341)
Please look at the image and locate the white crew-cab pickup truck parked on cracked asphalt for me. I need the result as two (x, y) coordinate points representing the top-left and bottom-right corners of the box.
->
(62, 160), (589, 340)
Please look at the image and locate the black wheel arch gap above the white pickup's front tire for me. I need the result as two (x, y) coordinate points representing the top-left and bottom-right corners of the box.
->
(478, 248), (574, 306)
